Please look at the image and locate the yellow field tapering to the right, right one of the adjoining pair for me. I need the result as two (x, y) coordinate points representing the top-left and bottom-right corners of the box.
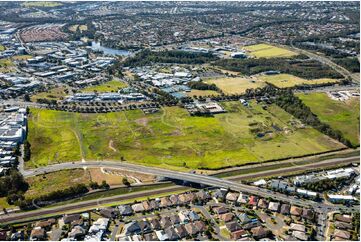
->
(257, 74), (340, 88)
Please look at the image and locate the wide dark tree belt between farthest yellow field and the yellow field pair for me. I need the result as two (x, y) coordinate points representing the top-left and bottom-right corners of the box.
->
(214, 55), (342, 79)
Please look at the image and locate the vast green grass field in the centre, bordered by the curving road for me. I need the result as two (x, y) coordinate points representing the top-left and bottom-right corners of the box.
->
(26, 102), (343, 170)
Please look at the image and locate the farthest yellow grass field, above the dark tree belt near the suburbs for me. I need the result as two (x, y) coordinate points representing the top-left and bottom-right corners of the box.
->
(243, 44), (297, 58)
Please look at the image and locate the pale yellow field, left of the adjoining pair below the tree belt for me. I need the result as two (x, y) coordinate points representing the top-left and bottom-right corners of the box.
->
(205, 77), (265, 94)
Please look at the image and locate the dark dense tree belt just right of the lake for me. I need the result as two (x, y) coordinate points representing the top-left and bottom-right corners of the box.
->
(124, 49), (218, 67)
